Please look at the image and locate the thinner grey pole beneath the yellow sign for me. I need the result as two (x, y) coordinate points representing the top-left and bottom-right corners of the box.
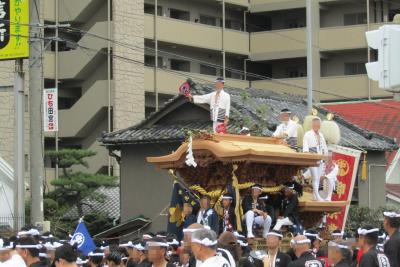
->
(14, 59), (25, 230)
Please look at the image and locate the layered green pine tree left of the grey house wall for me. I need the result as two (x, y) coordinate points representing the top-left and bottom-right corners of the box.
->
(44, 149), (118, 235)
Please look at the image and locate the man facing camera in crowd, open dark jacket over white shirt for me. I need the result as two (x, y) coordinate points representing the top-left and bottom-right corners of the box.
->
(254, 230), (292, 267)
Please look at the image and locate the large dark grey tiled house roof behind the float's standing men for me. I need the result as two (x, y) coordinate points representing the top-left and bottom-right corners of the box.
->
(101, 84), (396, 151)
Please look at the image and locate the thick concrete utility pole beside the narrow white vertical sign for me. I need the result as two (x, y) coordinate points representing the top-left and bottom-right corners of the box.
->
(29, 0), (44, 227)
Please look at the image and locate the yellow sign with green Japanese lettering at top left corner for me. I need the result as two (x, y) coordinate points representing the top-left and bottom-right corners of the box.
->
(0, 0), (29, 60)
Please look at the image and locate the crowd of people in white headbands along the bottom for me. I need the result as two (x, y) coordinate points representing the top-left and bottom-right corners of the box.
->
(0, 212), (400, 267)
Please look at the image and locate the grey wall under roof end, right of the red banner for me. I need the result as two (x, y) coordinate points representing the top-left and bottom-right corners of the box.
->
(358, 151), (386, 208)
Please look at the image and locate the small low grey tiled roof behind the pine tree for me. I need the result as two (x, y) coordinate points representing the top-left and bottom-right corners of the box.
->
(64, 186), (120, 219)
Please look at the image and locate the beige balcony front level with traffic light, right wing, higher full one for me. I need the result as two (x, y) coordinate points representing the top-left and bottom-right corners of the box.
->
(250, 24), (382, 61)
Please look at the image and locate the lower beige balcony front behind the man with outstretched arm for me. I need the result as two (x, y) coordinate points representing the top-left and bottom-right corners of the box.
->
(144, 67), (249, 95)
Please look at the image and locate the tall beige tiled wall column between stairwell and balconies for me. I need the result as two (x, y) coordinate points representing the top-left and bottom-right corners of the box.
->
(112, 0), (145, 130)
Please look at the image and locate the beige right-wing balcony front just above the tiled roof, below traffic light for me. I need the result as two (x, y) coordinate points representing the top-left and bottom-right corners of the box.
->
(252, 75), (392, 101)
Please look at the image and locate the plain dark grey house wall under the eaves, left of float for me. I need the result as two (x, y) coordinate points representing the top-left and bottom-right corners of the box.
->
(120, 143), (180, 232)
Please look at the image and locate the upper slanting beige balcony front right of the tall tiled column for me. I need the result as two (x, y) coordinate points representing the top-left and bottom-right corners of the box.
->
(144, 14), (249, 55)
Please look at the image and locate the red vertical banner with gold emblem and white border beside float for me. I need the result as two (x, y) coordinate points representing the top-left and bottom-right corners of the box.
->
(327, 146), (361, 231)
